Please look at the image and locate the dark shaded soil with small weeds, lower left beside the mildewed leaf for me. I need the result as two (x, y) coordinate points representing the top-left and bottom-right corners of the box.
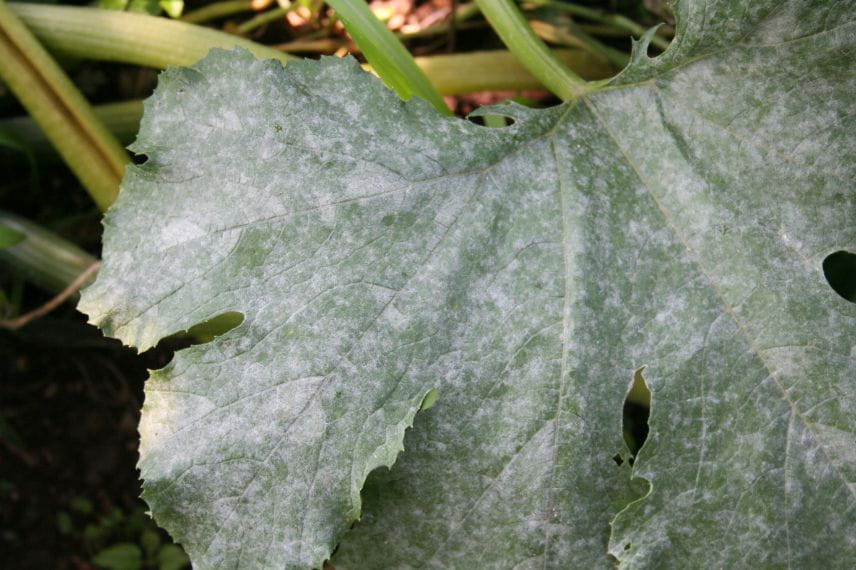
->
(0, 308), (185, 569)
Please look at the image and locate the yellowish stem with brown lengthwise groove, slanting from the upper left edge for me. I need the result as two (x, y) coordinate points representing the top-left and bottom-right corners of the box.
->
(0, 0), (128, 210)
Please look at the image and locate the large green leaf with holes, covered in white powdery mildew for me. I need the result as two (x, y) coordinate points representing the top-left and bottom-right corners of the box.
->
(81, 0), (856, 568)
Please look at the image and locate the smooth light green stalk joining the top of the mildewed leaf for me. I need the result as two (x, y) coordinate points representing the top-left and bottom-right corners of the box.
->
(476, 0), (593, 100)
